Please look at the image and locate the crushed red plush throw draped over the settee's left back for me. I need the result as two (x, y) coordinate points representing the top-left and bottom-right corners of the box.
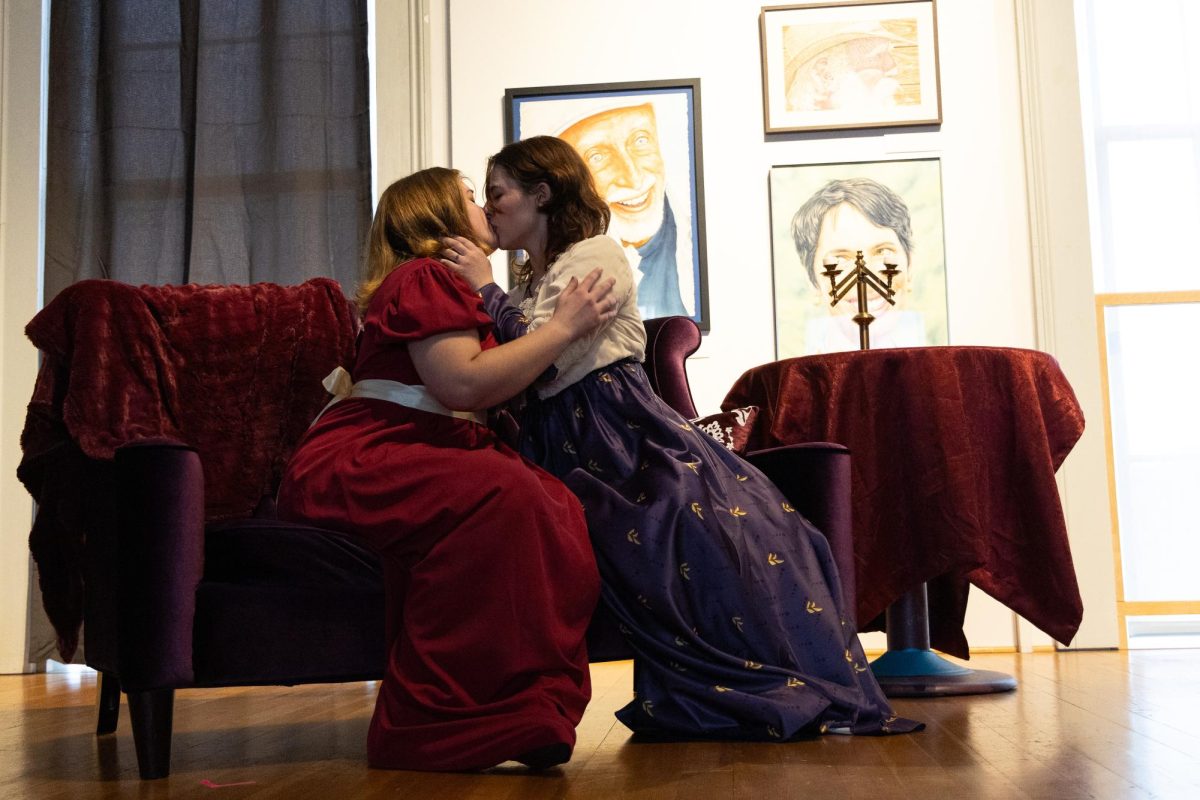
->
(17, 278), (356, 660)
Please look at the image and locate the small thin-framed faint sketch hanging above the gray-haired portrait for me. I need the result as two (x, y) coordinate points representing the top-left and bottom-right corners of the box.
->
(758, 0), (942, 133)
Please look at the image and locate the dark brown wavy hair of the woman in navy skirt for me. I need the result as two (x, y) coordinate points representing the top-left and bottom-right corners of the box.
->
(487, 136), (612, 281)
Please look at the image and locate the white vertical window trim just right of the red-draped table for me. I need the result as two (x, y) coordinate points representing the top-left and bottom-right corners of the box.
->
(1015, 0), (1120, 648)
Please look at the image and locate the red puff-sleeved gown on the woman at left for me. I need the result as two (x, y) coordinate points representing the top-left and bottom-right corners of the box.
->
(280, 259), (599, 770)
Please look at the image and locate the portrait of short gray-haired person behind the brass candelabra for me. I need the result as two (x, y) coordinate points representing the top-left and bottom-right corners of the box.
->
(770, 158), (949, 359)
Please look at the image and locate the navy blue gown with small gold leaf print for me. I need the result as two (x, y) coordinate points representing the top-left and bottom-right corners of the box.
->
(484, 277), (923, 741)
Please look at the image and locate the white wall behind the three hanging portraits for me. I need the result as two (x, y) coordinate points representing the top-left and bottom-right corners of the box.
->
(448, 0), (1108, 646)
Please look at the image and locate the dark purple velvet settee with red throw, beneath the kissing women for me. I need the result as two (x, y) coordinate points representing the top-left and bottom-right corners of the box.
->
(19, 291), (853, 778)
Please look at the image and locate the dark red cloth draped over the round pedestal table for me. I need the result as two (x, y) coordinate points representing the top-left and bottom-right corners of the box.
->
(722, 347), (1084, 657)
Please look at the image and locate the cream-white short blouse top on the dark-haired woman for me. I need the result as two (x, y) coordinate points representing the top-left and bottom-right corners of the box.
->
(509, 234), (646, 398)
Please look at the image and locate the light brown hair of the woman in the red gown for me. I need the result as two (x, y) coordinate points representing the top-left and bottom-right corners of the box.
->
(354, 167), (487, 311)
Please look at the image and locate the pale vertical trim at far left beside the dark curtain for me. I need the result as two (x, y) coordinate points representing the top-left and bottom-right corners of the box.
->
(0, 0), (42, 673)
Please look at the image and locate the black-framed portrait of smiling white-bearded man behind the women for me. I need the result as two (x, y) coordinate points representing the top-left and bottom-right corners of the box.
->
(504, 78), (709, 331)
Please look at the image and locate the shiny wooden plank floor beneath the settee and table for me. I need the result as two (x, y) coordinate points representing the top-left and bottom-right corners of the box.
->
(0, 650), (1200, 800)
